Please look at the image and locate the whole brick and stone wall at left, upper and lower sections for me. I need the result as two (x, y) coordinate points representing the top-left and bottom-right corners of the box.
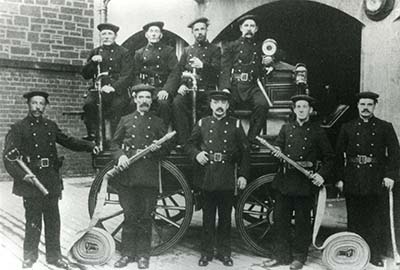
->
(0, 0), (94, 181)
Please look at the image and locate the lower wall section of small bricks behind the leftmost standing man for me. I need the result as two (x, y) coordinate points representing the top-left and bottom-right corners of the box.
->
(0, 68), (93, 180)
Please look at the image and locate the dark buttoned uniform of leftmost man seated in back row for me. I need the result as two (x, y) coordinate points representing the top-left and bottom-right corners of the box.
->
(82, 43), (132, 133)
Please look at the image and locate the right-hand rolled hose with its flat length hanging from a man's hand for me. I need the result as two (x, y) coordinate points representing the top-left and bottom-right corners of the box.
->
(313, 187), (371, 270)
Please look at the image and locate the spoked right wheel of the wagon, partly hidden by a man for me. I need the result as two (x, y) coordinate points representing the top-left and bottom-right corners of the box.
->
(235, 174), (275, 256)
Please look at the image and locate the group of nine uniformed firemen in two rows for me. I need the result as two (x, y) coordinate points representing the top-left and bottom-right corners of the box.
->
(3, 15), (400, 269)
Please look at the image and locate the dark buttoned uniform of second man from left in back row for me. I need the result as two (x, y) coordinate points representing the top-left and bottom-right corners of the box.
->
(133, 42), (178, 125)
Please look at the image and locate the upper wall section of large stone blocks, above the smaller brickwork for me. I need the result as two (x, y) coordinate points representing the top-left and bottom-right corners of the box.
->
(0, 0), (93, 65)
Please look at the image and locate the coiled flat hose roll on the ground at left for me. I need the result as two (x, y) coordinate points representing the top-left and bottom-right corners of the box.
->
(70, 227), (115, 265)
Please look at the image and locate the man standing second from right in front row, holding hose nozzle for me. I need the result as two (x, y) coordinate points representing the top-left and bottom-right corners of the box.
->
(266, 95), (335, 270)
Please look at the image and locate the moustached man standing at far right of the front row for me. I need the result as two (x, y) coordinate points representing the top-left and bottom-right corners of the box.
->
(336, 92), (400, 267)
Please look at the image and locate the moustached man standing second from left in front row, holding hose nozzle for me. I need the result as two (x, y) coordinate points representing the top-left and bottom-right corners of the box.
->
(111, 84), (167, 269)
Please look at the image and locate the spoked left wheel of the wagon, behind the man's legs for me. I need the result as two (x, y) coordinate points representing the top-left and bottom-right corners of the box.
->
(88, 161), (193, 255)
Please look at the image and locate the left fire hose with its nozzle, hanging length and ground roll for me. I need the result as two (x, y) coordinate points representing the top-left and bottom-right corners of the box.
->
(68, 131), (176, 265)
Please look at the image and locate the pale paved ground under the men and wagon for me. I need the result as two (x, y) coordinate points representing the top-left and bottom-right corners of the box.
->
(0, 178), (395, 270)
